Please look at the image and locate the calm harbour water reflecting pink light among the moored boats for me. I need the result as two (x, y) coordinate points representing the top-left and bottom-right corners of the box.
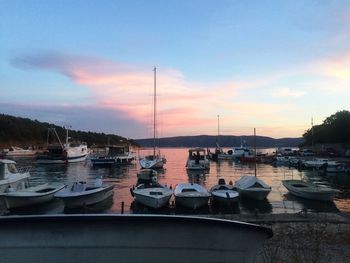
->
(3, 148), (350, 217)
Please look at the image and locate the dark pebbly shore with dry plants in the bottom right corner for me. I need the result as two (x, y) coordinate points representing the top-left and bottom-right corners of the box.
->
(205, 212), (350, 263)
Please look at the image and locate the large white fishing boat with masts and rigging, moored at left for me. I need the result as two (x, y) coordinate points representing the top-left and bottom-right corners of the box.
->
(36, 128), (89, 164)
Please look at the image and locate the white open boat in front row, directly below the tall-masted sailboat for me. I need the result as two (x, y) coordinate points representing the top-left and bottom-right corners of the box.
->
(131, 182), (173, 209)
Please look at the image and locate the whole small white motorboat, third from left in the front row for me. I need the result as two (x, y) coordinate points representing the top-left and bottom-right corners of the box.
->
(54, 179), (114, 208)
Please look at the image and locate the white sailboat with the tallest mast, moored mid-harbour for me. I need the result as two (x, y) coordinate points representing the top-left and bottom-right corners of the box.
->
(140, 67), (166, 169)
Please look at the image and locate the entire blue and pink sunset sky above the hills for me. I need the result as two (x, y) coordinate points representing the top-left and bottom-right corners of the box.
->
(0, 0), (350, 139)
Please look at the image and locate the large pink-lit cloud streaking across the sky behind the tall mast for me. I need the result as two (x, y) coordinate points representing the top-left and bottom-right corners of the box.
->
(11, 52), (314, 138)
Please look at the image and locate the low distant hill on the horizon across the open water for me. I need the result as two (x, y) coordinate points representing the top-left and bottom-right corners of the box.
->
(135, 135), (304, 147)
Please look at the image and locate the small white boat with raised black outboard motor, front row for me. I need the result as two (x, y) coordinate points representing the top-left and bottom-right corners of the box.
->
(210, 178), (239, 203)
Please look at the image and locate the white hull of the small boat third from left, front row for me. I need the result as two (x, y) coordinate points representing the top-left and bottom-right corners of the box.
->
(55, 185), (114, 208)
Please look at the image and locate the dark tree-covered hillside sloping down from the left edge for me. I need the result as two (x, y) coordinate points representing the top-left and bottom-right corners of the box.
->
(0, 114), (134, 147)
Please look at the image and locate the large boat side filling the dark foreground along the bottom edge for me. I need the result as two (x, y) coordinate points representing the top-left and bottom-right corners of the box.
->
(0, 214), (273, 263)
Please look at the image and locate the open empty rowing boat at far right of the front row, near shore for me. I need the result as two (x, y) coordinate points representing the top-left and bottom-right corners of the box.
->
(282, 180), (338, 201)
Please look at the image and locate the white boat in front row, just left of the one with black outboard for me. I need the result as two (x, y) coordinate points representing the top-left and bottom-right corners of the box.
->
(174, 183), (210, 209)
